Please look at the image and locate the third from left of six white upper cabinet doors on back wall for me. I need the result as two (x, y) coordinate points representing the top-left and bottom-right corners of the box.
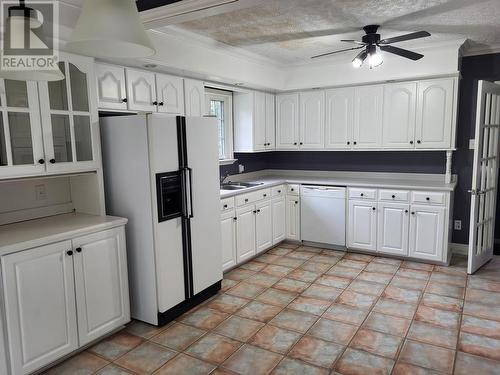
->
(325, 88), (354, 149)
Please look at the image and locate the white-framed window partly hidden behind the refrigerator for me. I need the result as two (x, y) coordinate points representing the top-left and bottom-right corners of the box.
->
(205, 89), (234, 163)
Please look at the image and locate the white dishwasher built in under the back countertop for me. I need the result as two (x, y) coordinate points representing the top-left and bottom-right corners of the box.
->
(300, 185), (346, 247)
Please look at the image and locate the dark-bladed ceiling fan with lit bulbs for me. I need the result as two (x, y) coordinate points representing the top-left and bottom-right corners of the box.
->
(312, 25), (431, 68)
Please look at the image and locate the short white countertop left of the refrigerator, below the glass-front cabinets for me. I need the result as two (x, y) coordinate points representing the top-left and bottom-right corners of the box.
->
(0, 213), (128, 256)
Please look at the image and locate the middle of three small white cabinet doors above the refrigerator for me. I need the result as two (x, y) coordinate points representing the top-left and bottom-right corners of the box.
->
(126, 68), (157, 112)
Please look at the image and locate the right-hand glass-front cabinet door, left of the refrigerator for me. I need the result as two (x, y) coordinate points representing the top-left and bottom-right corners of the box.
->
(39, 52), (100, 172)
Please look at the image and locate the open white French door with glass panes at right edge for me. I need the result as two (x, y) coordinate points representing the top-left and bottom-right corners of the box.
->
(468, 81), (500, 273)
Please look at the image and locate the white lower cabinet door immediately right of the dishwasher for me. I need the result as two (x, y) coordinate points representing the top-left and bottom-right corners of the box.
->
(347, 201), (377, 251)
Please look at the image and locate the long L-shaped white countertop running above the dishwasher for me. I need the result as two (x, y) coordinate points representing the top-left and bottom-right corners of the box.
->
(221, 170), (457, 198)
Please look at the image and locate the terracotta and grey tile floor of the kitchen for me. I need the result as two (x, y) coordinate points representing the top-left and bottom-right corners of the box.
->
(42, 243), (500, 375)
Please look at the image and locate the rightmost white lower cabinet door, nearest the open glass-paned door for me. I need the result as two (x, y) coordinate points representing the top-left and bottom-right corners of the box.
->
(409, 205), (447, 262)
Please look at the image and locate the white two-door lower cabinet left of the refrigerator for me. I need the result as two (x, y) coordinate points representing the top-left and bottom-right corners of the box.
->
(1, 227), (130, 375)
